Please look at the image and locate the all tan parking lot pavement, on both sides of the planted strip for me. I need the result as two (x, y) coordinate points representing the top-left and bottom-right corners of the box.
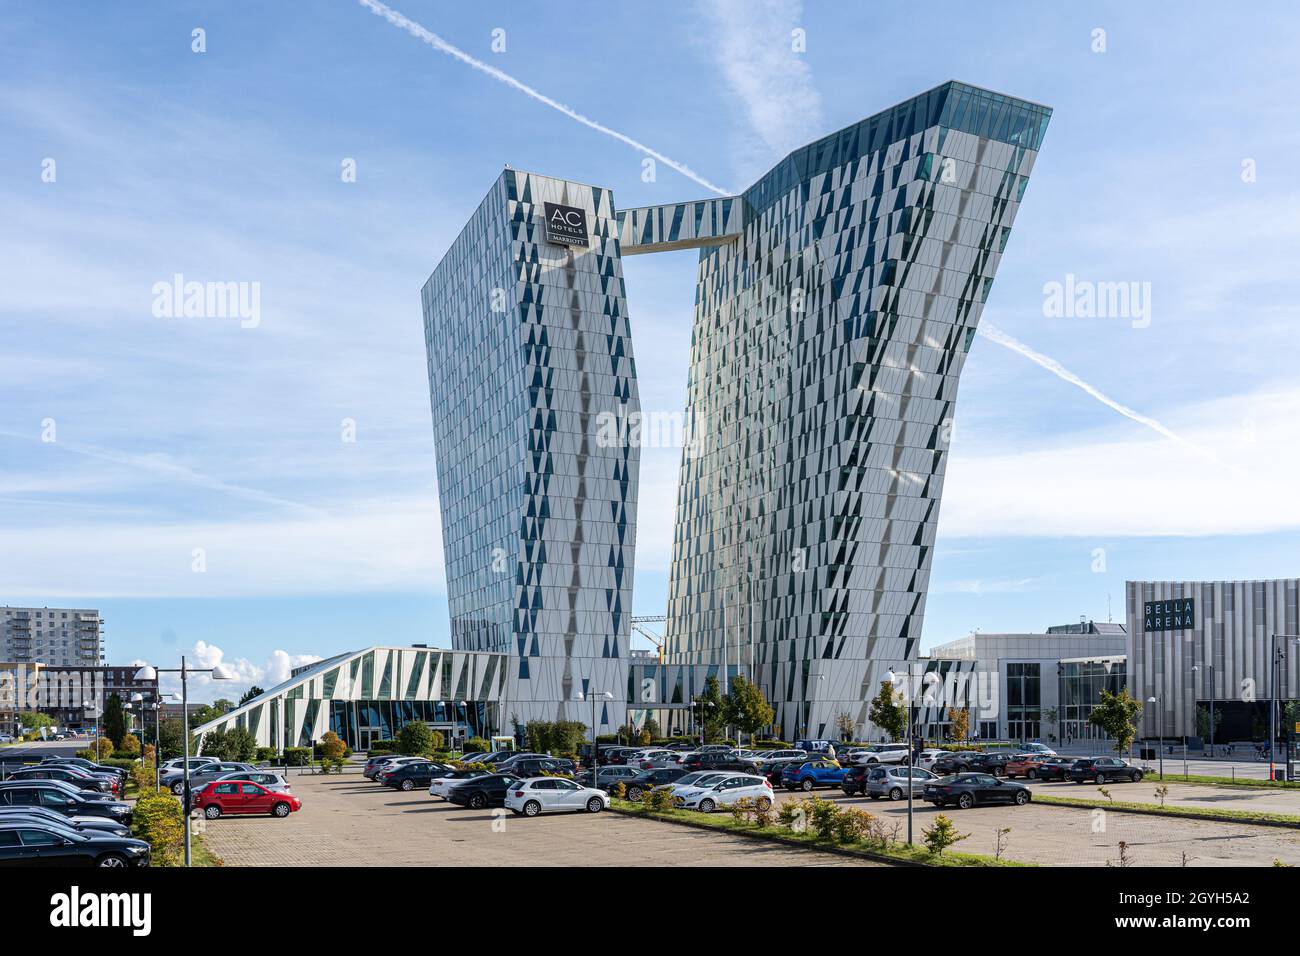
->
(196, 773), (1300, 866)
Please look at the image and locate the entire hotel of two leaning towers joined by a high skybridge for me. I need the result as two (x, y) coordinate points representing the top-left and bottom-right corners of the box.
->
(423, 82), (1050, 737)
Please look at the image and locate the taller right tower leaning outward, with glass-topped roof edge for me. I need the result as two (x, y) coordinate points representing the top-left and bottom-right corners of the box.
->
(644, 82), (1050, 739)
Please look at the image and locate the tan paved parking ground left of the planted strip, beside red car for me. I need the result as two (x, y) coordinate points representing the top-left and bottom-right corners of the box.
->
(195, 774), (876, 866)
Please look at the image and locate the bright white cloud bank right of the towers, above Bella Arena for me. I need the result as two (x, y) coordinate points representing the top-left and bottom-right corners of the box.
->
(939, 390), (1300, 538)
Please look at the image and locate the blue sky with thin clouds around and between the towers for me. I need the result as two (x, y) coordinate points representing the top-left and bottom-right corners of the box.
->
(0, 0), (1300, 693)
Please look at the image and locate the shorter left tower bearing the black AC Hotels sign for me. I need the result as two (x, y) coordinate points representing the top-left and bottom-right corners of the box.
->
(421, 169), (640, 730)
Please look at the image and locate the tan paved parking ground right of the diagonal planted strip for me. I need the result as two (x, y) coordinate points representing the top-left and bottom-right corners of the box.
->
(779, 780), (1300, 866)
